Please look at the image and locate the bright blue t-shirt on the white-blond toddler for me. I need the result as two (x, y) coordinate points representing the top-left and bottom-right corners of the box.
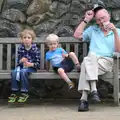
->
(46, 48), (67, 67)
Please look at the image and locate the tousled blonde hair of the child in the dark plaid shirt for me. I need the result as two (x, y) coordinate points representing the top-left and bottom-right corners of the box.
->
(20, 29), (36, 40)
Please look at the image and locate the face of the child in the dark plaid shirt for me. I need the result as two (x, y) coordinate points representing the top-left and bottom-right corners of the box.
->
(22, 33), (32, 46)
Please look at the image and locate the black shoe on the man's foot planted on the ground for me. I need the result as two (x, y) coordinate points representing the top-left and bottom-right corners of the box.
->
(78, 100), (89, 112)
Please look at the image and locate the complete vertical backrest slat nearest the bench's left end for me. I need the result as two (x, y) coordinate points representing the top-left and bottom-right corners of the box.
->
(7, 44), (11, 70)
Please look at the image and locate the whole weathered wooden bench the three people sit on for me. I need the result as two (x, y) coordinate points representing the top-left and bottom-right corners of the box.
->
(0, 37), (120, 105)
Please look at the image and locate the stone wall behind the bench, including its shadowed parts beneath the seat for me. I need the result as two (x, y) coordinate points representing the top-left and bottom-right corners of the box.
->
(0, 0), (120, 98)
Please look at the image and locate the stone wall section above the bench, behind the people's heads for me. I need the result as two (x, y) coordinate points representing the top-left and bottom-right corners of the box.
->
(0, 0), (120, 37)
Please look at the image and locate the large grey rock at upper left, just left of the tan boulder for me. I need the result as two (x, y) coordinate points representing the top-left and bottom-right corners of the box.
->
(1, 9), (26, 23)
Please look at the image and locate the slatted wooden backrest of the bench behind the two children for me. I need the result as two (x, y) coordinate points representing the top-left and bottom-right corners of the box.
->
(0, 37), (87, 71)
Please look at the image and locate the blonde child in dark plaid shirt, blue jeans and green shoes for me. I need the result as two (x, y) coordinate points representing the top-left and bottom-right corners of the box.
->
(8, 29), (40, 102)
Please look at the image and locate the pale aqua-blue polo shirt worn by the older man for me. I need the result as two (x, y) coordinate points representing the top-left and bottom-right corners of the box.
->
(83, 25), (120, 57)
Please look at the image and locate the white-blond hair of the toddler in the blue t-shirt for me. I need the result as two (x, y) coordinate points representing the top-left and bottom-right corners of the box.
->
(46, 34), (59, 44)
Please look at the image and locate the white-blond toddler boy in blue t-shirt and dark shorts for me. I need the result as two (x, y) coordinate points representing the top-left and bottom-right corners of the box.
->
(46, 34), (80, 90)
